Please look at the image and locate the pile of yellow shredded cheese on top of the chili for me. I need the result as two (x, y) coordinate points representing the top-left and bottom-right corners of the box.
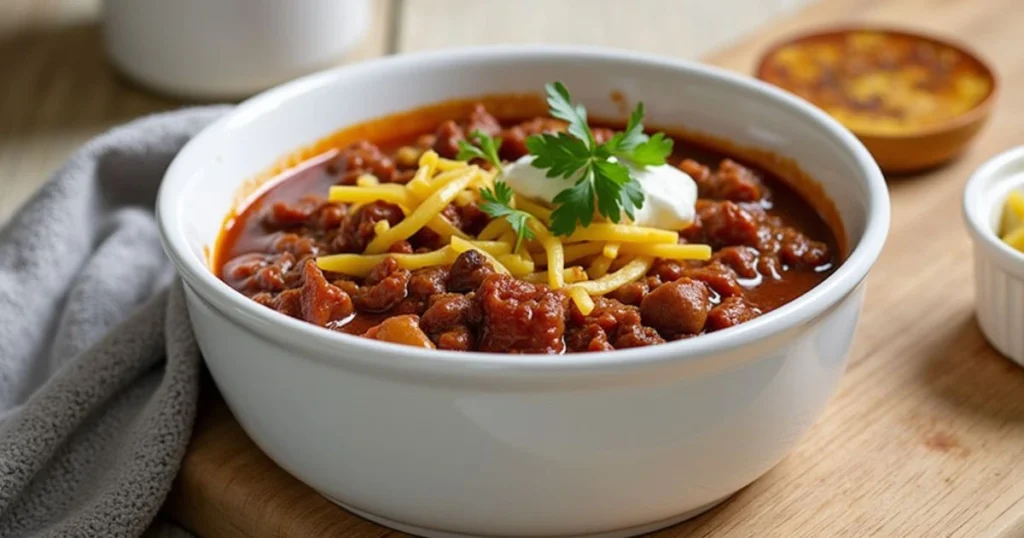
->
(316, 151), (712, 315)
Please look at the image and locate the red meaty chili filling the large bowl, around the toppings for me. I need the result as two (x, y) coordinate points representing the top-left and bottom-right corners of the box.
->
(214, 99), (842, 354)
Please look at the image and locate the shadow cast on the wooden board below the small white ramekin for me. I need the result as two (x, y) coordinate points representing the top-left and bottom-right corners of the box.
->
(917, 312), (1024, 424)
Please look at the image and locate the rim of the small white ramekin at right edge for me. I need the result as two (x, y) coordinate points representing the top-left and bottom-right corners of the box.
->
(962, 146), (1024, 278)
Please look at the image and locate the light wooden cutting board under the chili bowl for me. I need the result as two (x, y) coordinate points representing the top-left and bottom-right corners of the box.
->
(161, 0), (1024, 538)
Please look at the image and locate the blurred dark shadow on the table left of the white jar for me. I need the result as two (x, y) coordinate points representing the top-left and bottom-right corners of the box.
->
(0, 23), (184, 143)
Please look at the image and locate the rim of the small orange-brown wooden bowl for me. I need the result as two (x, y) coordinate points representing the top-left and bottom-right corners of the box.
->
(754, 24), (1000, 141)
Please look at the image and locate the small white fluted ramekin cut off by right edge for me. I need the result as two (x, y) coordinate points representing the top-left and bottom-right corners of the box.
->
(964, 147), (1024, 366)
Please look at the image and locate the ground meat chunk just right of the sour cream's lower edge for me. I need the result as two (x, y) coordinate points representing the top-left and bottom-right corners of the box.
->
(682, 200), (761, 249)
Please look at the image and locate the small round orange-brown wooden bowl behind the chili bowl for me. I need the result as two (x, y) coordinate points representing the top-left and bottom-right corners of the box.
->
(757, 28), (998, 173)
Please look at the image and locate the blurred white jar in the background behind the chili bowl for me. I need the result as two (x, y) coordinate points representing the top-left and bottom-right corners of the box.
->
(102, 0), (371, 99)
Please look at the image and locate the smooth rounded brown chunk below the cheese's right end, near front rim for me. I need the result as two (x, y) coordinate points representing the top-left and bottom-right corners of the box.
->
(640, 277), (711, 336)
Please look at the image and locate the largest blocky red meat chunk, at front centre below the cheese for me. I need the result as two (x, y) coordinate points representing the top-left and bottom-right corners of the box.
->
(471, 270), (568, 354)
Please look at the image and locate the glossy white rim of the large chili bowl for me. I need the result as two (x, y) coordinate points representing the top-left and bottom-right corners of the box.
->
(157, 45), (890, 378)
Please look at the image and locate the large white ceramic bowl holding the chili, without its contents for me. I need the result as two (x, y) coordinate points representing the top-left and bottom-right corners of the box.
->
(158, 47), (889, 536)
